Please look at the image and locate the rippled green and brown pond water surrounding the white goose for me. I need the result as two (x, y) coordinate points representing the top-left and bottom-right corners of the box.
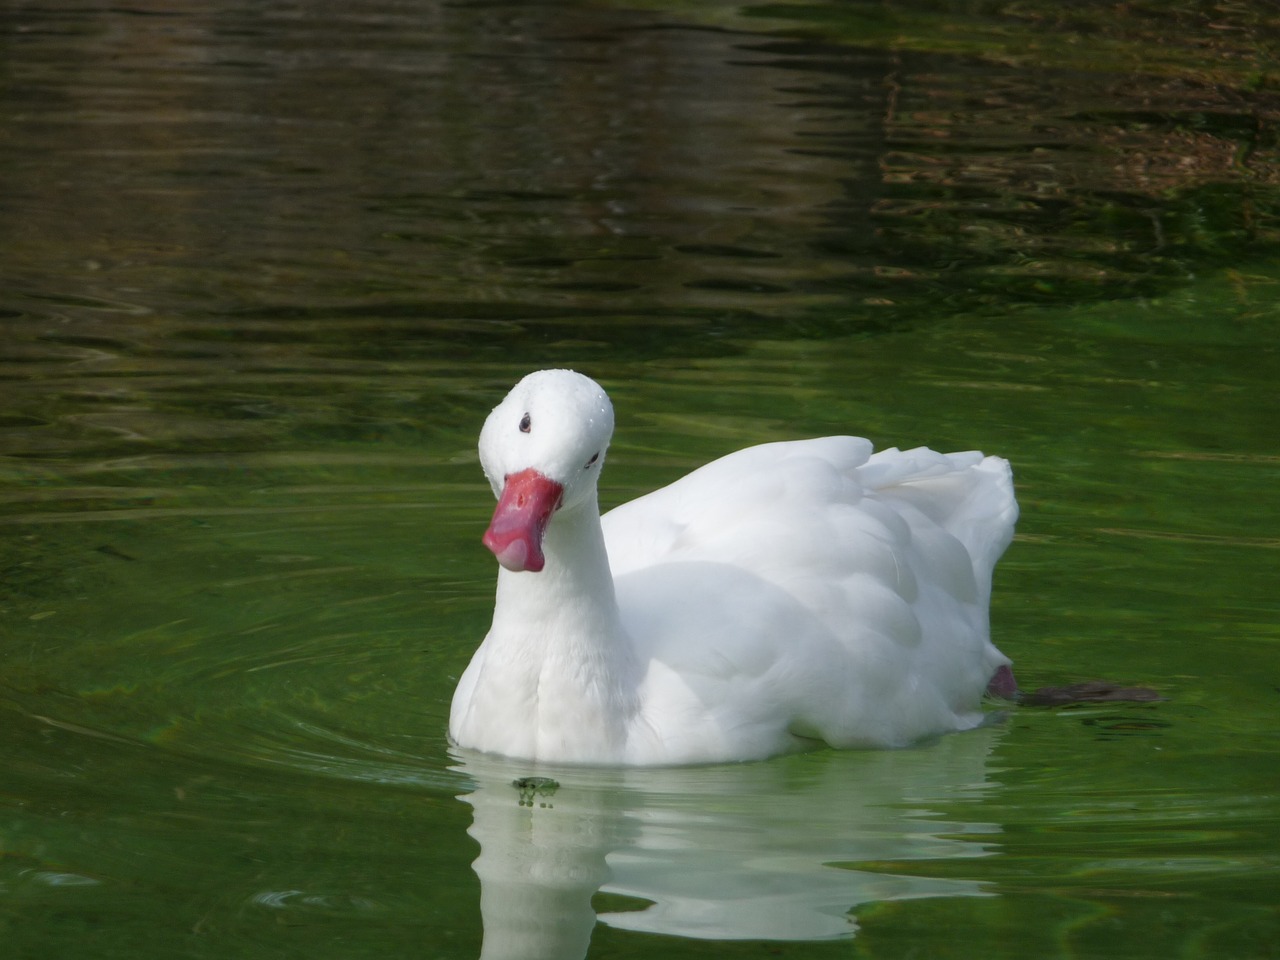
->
(0, 0), (1280, 959)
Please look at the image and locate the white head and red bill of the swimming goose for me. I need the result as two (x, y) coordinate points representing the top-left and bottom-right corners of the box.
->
(480, 370), (613, 571)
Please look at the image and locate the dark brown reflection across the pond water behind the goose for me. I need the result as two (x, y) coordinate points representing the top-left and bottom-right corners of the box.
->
(0, 0), (1280, 457)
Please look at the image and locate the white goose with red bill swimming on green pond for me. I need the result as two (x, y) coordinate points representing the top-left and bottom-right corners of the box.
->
(449, 370), (1018, 764)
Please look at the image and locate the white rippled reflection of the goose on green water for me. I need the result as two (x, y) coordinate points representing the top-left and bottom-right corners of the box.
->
(456, 727), (1001, 960)
